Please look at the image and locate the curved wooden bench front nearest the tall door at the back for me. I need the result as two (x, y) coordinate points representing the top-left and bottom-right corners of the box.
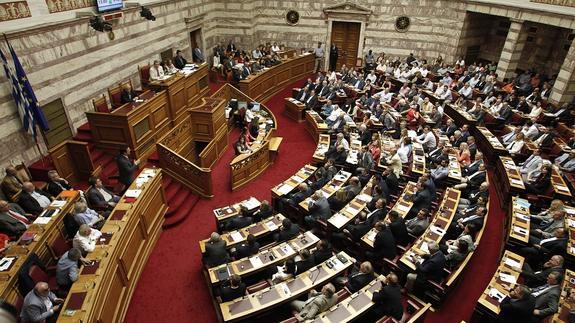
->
(239, 53), (315, 101)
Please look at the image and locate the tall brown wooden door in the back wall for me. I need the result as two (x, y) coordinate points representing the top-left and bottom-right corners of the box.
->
(331, 21), (361, 70)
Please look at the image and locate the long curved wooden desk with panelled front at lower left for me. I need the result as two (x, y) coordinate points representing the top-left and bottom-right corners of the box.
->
(58, 168), (168, 322)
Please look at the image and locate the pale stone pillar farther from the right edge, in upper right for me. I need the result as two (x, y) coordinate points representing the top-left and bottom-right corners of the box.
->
(497, 19), (527, 80)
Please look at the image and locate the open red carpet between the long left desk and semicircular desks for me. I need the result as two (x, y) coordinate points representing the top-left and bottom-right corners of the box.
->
(126, 80), (315, 323)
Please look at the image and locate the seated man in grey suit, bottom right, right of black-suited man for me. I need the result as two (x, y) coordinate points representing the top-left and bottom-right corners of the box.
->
(531, 271), (562, 320)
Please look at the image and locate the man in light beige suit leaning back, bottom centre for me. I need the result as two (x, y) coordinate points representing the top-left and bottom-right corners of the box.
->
(290, 283), (337, 322)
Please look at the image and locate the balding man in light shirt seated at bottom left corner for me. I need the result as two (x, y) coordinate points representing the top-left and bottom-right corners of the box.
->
(20, 282), (64, 323)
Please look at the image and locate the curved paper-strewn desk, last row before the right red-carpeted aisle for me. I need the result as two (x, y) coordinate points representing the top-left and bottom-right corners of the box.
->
(399, 187), (461, 270)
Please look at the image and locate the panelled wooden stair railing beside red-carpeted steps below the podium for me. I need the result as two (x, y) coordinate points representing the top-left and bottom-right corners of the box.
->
(156, 143), (214, 197)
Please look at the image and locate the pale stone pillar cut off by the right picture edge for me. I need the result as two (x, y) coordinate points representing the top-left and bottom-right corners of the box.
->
(549, 40), (575, 103)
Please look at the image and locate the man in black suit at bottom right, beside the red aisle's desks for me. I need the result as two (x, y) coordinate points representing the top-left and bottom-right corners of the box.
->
(499, 285), (535, 323)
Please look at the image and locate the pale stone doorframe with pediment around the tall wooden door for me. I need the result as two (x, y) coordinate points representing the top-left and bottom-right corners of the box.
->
(323, 1), (373, 70)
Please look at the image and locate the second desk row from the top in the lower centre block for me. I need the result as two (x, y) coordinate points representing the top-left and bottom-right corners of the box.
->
(199, 213), (285, 253)
